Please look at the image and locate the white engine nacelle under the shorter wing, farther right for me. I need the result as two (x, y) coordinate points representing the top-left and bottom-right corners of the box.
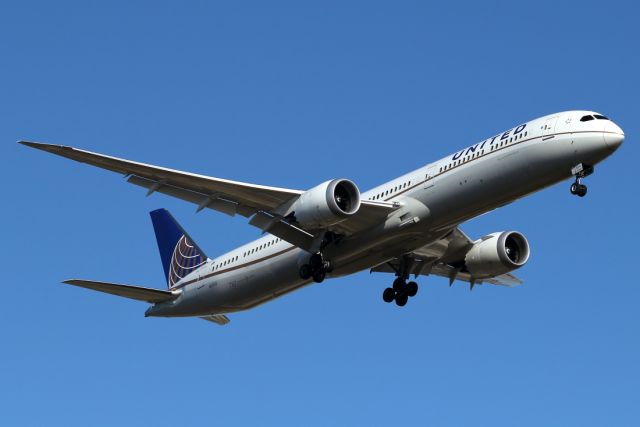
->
(464, 231), (530, 279)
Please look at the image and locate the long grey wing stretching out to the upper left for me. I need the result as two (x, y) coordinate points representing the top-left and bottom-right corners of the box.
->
(18, 141), (397, 249)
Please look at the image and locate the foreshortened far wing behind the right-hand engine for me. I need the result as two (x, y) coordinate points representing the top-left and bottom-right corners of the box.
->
(371, 227), (523, 287)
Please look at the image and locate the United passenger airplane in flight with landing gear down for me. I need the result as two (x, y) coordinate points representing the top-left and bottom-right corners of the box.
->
(18, 111), (624, 325)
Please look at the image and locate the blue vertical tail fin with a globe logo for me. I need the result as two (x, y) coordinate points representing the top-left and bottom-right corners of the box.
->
(150, 209), (207, 289)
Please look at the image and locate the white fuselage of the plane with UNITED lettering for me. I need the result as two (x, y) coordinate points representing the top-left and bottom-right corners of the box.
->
(147, 111), (623, 316)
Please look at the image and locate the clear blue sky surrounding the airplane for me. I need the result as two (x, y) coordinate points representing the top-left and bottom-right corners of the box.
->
(0, 1), (640, 427)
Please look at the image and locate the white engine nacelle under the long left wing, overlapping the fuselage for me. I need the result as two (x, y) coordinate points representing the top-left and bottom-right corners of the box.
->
(289, 179), (360, 228)
